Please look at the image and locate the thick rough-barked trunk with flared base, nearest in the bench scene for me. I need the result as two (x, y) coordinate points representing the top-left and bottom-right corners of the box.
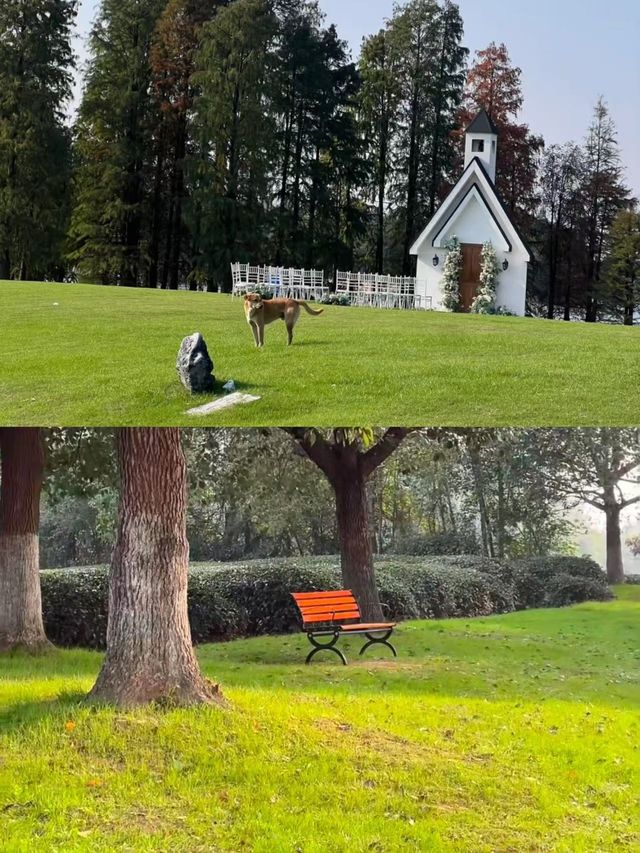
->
(89, 429), (221, 707)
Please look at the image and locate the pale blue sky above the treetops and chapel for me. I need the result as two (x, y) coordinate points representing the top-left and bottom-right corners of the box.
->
(72, 0), (640, 196)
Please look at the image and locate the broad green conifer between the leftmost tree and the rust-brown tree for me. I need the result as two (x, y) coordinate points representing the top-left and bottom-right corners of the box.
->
(69, 0), (163, 286)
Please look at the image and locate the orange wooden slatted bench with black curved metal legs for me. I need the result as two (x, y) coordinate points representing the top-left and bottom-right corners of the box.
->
(291, 589), (397, 666)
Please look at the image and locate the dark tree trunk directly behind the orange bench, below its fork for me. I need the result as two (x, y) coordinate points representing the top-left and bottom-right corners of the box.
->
(331, 456), (383, 622)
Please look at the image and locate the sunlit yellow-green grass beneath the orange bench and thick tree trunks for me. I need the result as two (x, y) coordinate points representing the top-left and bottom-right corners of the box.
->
(0, 587), (640, 853)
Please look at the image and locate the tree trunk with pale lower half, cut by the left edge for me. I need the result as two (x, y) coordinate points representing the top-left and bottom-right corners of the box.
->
(0, 427), (49, 651)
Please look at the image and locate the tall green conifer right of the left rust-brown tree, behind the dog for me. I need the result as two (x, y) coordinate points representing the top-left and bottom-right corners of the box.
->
(190, 0), (277, 283)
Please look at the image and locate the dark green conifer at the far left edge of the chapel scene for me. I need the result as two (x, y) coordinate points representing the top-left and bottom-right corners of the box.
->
(0, 0), (77, 279)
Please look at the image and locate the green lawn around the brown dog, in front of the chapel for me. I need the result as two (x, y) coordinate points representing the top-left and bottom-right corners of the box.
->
(0, 282), (640, 427)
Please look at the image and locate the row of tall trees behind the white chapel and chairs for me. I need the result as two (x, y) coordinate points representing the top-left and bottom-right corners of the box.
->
(0, 0), (640, 322)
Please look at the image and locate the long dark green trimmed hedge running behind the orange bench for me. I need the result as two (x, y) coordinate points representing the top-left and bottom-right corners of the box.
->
(42, 555), (610, 649)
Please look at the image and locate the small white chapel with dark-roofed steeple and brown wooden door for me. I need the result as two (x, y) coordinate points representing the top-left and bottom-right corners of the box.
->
(411, 110), (531, 317)
